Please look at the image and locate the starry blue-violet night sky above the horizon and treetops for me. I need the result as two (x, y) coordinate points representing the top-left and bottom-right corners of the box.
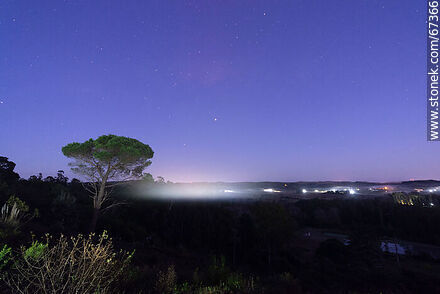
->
(0, 0), (434, 181)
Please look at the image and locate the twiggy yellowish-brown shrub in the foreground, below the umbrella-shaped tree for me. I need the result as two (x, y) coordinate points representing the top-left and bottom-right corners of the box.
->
(5, 232), (133, 294)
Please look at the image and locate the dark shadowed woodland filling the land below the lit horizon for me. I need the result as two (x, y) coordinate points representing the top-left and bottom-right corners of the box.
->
(0, 157), (440, 293)
